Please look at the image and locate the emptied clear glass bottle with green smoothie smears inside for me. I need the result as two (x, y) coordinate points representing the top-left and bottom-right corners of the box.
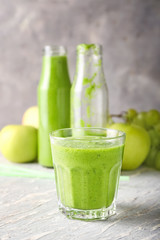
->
(71, 44), (108, 128)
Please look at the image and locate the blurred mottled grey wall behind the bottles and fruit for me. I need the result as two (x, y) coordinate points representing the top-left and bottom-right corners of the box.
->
(0, 0), (160, 127)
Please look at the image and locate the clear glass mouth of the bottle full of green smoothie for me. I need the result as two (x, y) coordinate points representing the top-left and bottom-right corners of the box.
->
(44, 45), (66, 56)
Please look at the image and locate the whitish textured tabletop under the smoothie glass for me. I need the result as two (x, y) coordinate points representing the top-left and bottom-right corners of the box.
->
(0, 156), (160, 240)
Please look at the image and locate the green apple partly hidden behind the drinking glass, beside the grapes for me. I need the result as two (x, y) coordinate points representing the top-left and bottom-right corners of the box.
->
(110, 123), (150, 170)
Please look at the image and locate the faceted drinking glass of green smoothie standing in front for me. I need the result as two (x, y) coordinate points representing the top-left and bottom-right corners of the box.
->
(50, 128), (125, 220)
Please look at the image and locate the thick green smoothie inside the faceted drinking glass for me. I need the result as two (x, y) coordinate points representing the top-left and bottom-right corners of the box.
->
(52, 142), (124, 210)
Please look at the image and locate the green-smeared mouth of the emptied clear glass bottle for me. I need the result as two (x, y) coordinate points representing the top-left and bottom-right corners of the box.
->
(77, 43), (102, 55)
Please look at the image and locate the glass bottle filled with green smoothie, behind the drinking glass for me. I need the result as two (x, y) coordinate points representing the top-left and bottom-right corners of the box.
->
(38, 46), (71, 167)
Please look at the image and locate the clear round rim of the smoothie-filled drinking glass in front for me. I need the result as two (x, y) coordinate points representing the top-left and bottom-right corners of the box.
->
(49, 127), (126, 142)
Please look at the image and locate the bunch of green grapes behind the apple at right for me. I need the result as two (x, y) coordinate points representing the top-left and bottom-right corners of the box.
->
(123, 109), (160, 170)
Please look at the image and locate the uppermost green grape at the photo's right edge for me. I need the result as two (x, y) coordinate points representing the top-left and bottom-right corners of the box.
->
(146, 109), (160, 128)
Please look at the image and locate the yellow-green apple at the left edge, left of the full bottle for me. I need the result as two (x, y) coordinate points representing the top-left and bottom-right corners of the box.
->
(0, 125), (37, 163)
